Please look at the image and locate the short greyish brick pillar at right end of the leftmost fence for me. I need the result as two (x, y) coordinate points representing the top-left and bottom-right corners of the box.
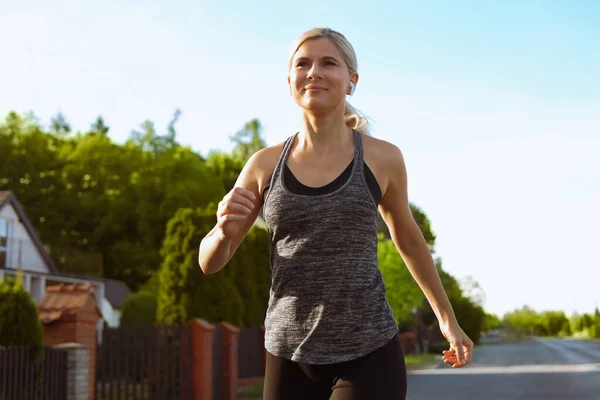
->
(53, 343), (91, 400)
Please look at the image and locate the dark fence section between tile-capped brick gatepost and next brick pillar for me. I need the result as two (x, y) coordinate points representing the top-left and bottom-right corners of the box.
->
(96, 326), (193, 400)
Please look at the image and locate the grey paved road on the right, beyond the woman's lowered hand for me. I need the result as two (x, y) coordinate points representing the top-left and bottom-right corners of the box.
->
(407, 339), (600, 400)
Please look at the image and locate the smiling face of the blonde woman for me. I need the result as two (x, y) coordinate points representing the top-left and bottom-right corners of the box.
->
(288, 38), (358, 114)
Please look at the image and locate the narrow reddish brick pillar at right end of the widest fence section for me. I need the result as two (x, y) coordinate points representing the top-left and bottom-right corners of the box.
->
(188, 319), (215, 400)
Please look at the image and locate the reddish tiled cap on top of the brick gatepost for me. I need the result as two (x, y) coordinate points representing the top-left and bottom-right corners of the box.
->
(37, 283), (99, 324)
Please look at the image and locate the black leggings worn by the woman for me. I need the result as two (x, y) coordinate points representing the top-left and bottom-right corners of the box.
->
(263, 335), (406, 400)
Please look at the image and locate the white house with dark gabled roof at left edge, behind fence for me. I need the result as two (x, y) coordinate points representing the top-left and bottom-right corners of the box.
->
(0, 191), (131, 327)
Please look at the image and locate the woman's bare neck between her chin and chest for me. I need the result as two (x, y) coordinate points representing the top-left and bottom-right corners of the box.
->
(298, 107), (354, 155)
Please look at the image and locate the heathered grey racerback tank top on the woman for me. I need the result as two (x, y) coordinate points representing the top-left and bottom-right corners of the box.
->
(263, 131), (398, 364)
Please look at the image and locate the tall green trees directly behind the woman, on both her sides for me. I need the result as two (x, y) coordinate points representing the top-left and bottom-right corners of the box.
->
(0, 111), (498, 340)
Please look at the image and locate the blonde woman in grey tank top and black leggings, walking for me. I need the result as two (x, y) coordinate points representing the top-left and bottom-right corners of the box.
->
(199, 29), (473, 400)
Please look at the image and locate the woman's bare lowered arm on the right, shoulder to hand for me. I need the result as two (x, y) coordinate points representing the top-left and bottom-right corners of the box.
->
(379, 143), (473, 368)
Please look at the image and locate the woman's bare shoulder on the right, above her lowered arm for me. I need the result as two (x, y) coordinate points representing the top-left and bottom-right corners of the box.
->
(362, 135), (406, 196)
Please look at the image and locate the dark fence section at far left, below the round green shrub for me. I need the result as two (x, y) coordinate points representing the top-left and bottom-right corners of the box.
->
(0, 348), (67, 400)
